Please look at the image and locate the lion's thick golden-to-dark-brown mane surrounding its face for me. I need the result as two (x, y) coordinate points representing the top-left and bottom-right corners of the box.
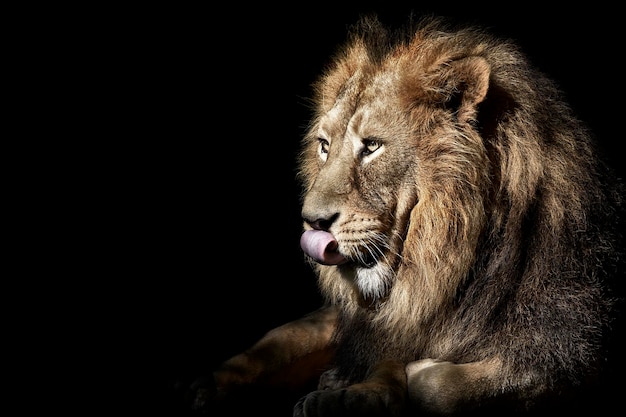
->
(299, 13), (622, 385)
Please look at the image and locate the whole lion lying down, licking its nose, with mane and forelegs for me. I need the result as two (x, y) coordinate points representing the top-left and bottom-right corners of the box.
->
(192, 16), (624, 417)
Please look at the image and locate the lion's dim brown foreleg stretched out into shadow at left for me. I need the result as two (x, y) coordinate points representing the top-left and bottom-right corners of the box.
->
(213, 307), (337, 394)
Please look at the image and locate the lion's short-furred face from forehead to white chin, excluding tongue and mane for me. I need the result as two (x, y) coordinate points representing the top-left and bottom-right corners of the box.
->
(302, 65), (418, 298)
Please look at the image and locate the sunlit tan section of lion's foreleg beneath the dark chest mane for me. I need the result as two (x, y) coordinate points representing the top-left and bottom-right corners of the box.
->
(406, 359), (504, 415)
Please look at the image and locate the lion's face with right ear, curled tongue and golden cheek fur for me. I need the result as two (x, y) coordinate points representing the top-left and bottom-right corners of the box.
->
(300, 31), (492, 306)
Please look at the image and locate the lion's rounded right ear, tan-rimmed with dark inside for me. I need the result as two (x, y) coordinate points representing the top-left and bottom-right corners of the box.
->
(434, 56), (491, 122)
